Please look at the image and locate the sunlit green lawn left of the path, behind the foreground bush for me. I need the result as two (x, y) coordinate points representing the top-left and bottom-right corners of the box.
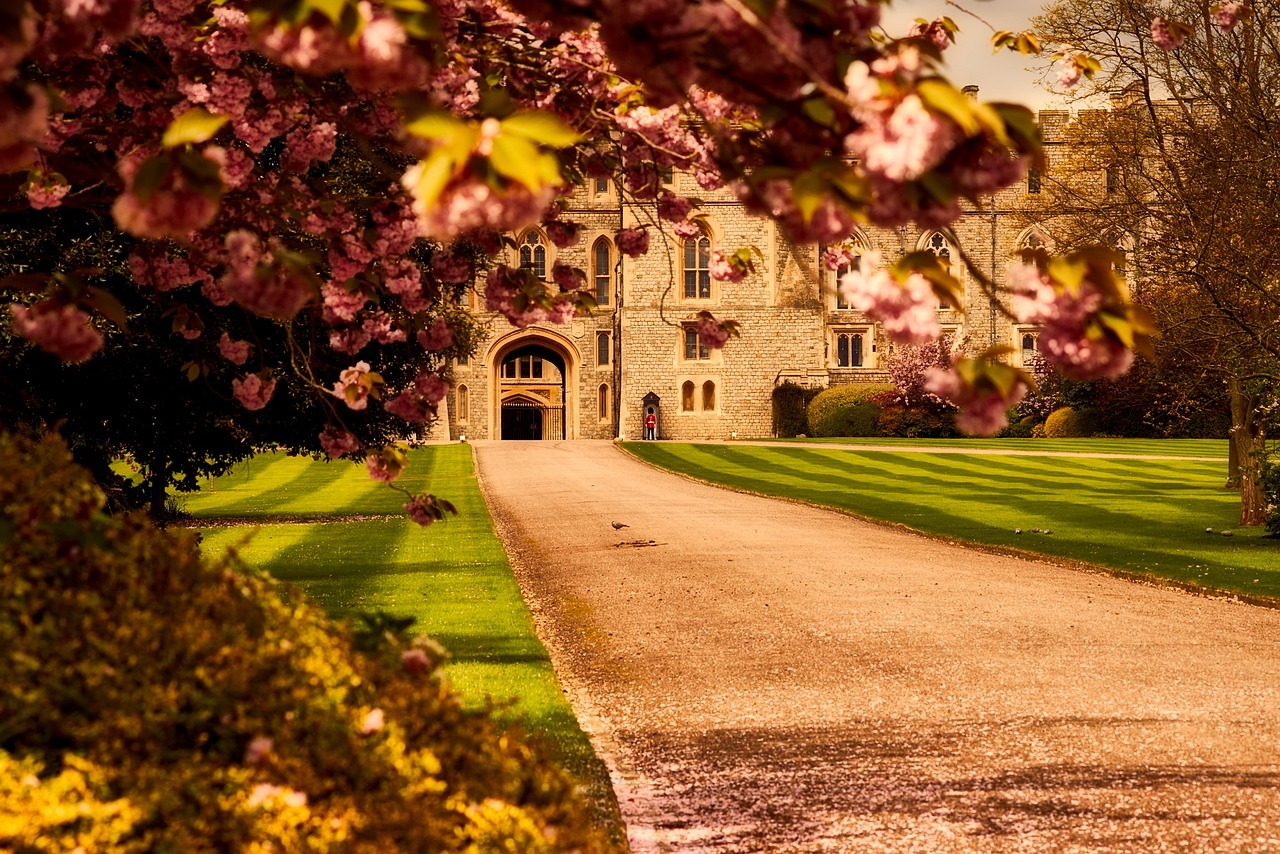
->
(184, 446), (623, 840)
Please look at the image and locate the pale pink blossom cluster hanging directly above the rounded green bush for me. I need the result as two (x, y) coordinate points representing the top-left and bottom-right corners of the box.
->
(840, 252), (942, 344)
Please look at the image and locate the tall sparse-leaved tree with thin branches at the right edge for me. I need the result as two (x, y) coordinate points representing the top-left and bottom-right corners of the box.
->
(1036, 0), (1280, 525)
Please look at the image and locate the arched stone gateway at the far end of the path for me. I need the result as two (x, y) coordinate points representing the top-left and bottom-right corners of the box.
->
(488, 329), (579, 440)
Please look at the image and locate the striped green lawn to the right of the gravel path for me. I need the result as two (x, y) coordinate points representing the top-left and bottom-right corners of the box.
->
(625, 439), (1280, 600)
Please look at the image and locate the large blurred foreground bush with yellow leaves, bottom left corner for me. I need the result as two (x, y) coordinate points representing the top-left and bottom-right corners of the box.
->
(0, 437), (604, 851)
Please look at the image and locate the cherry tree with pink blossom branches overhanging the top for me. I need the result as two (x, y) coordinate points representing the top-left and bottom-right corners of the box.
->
(0, 0), (1177, 508)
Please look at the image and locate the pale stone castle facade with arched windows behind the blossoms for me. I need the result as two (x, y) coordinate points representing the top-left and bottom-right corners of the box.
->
(447, 113), (1069, 440)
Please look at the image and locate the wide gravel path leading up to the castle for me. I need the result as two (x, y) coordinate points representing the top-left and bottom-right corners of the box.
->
(476, 442), (1280, 854)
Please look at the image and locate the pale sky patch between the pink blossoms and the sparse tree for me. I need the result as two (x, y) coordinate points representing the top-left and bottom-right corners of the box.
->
(881, 0), (1066, 109)
